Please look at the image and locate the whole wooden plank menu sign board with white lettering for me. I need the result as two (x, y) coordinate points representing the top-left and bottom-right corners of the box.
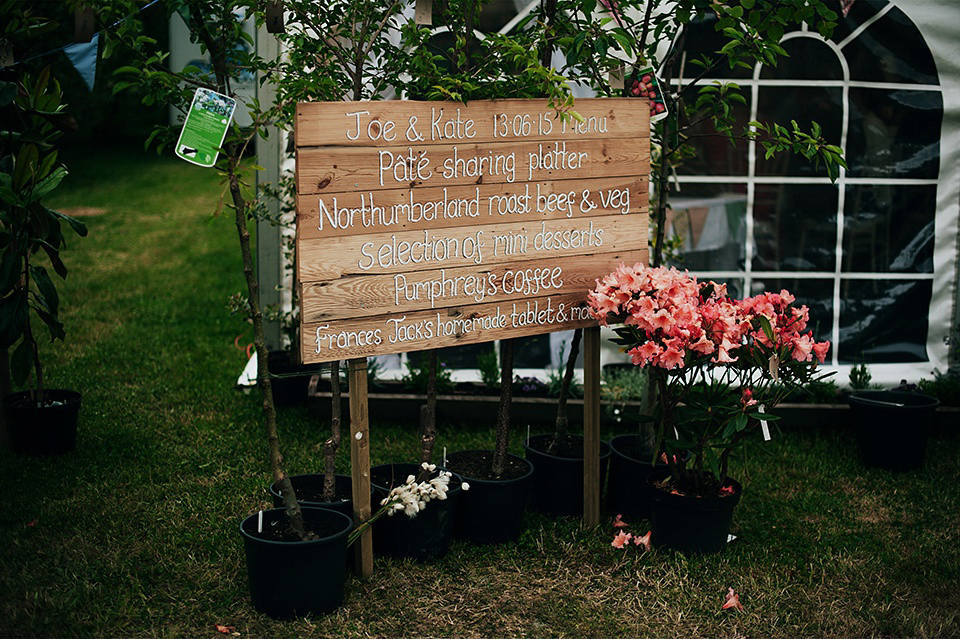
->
(295, 99), (650, 363)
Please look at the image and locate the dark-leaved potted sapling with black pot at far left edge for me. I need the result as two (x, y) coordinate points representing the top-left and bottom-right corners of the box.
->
(0, 67), (87, 454)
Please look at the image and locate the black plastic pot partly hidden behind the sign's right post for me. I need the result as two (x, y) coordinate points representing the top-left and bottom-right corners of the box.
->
(523, 433), (610, 517)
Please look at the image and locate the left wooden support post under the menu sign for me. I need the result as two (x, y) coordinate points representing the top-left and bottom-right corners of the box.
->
(347, 357), (373, 579)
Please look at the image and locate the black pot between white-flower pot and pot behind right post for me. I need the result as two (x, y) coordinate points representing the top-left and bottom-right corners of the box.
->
(447, 451), (534, 544)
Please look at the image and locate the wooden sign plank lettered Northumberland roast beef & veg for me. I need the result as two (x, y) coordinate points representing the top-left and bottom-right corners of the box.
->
(297, 176), (649, 240)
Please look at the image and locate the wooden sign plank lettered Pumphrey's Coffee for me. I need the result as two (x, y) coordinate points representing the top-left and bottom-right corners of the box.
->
(300, 250), (647, 323)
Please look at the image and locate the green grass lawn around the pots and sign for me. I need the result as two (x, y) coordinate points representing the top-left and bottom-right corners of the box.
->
(0, 149), (960, 639)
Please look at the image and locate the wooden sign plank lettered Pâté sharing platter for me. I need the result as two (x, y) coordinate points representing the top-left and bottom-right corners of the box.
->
(296, 138), (650, 195)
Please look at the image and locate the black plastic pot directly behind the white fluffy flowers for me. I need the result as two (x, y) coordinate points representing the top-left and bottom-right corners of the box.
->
(370, 464), (463, 563)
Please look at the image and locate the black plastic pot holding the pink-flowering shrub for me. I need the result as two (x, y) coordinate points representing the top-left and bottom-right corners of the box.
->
(647, 471), (743, 555)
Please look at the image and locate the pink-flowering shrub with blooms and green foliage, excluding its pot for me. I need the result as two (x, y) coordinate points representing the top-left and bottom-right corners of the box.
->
(588, 264), (830, 495)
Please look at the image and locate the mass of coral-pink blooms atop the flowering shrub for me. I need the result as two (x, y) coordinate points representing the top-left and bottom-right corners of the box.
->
(588, 263), (830, 370)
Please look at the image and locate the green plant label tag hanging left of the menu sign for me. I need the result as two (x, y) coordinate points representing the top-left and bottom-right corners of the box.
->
(176, 88), (237, 167)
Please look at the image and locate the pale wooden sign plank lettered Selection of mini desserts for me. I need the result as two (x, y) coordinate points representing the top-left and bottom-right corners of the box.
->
(297, 215), (647, 282)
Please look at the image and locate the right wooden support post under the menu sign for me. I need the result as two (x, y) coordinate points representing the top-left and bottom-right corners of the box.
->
(583, 326), (602, 527)
